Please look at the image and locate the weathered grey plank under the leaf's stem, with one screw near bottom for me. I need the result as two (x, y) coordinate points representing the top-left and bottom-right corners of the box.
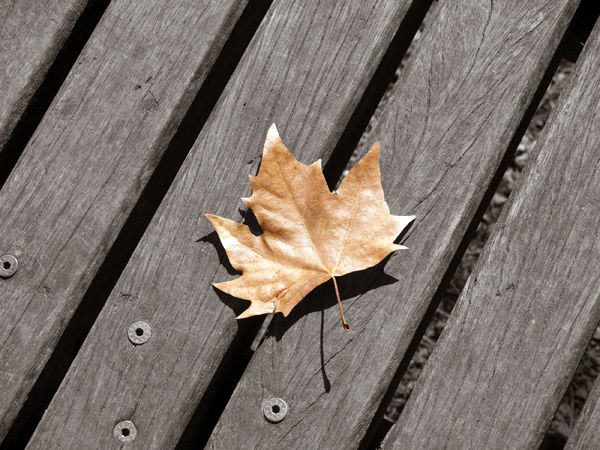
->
(209, 0), (576, 449)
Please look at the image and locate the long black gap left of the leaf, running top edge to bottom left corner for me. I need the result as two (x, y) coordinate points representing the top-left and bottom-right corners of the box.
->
(0, 0), (271, 449)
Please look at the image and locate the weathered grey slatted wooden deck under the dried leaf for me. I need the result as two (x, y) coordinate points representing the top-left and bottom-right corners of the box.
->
(0, 0), (600, 449)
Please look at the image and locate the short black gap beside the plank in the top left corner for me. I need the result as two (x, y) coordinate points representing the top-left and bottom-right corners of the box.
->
(0, 0), (110, 189)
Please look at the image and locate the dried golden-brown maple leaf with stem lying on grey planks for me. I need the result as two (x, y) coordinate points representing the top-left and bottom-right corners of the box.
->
(206, 125), (415, 329)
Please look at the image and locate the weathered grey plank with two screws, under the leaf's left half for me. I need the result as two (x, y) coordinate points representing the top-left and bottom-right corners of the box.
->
(30, 0), (422, 448)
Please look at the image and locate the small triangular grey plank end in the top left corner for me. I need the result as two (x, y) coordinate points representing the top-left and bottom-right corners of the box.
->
(0, 0), (87, 149)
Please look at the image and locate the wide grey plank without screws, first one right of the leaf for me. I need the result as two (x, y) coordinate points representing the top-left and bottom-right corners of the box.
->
(388, 18), (600, 449)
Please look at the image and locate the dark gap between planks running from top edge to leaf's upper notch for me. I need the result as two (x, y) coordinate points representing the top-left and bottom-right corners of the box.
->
(323, 0), (433, 190)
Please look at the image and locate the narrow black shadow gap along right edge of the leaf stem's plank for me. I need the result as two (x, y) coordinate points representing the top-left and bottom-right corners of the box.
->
(359, 0), (594, 450)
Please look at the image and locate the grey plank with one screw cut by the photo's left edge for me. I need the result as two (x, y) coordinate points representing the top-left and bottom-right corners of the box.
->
(0, 0), (246, 437)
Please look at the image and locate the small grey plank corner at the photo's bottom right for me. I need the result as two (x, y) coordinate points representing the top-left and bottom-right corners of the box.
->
(565, 370), (600, 450)
